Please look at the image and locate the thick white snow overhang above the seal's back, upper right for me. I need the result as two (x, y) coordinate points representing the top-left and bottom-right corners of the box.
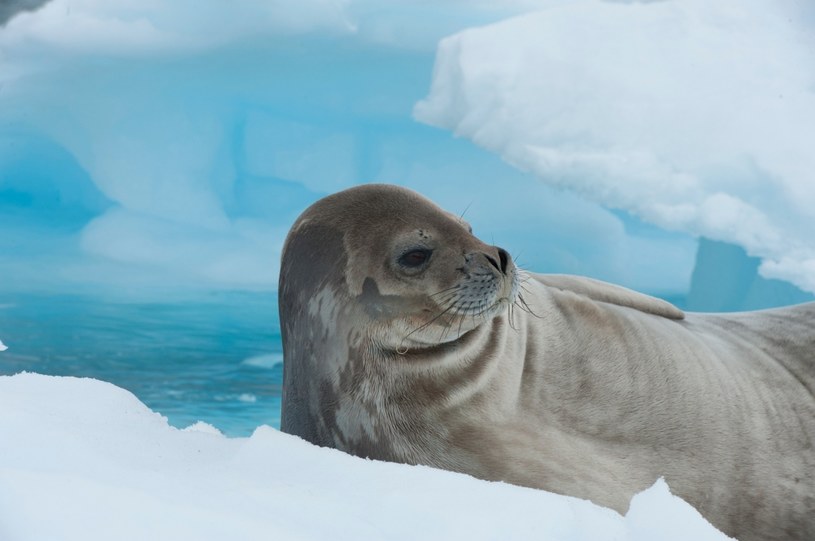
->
(414, 0), (815, 292)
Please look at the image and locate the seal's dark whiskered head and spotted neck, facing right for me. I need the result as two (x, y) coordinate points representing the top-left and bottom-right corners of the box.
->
(279, 184), (519, 456)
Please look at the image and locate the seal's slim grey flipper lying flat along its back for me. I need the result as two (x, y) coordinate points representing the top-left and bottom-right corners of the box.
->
(529, 273), (685, 319)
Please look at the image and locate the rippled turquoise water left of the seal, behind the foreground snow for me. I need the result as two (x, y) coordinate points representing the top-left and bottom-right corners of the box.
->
(0, 293), (283, 436)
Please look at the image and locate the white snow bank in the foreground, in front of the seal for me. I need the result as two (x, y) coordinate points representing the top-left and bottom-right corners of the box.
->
(0, 373), (727, 541)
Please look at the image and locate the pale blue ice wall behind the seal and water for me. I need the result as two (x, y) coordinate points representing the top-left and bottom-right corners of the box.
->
(0, 0), (696, 295)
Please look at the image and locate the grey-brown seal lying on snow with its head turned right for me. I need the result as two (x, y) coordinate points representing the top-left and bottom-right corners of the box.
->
(279, 185), (815, 540)
